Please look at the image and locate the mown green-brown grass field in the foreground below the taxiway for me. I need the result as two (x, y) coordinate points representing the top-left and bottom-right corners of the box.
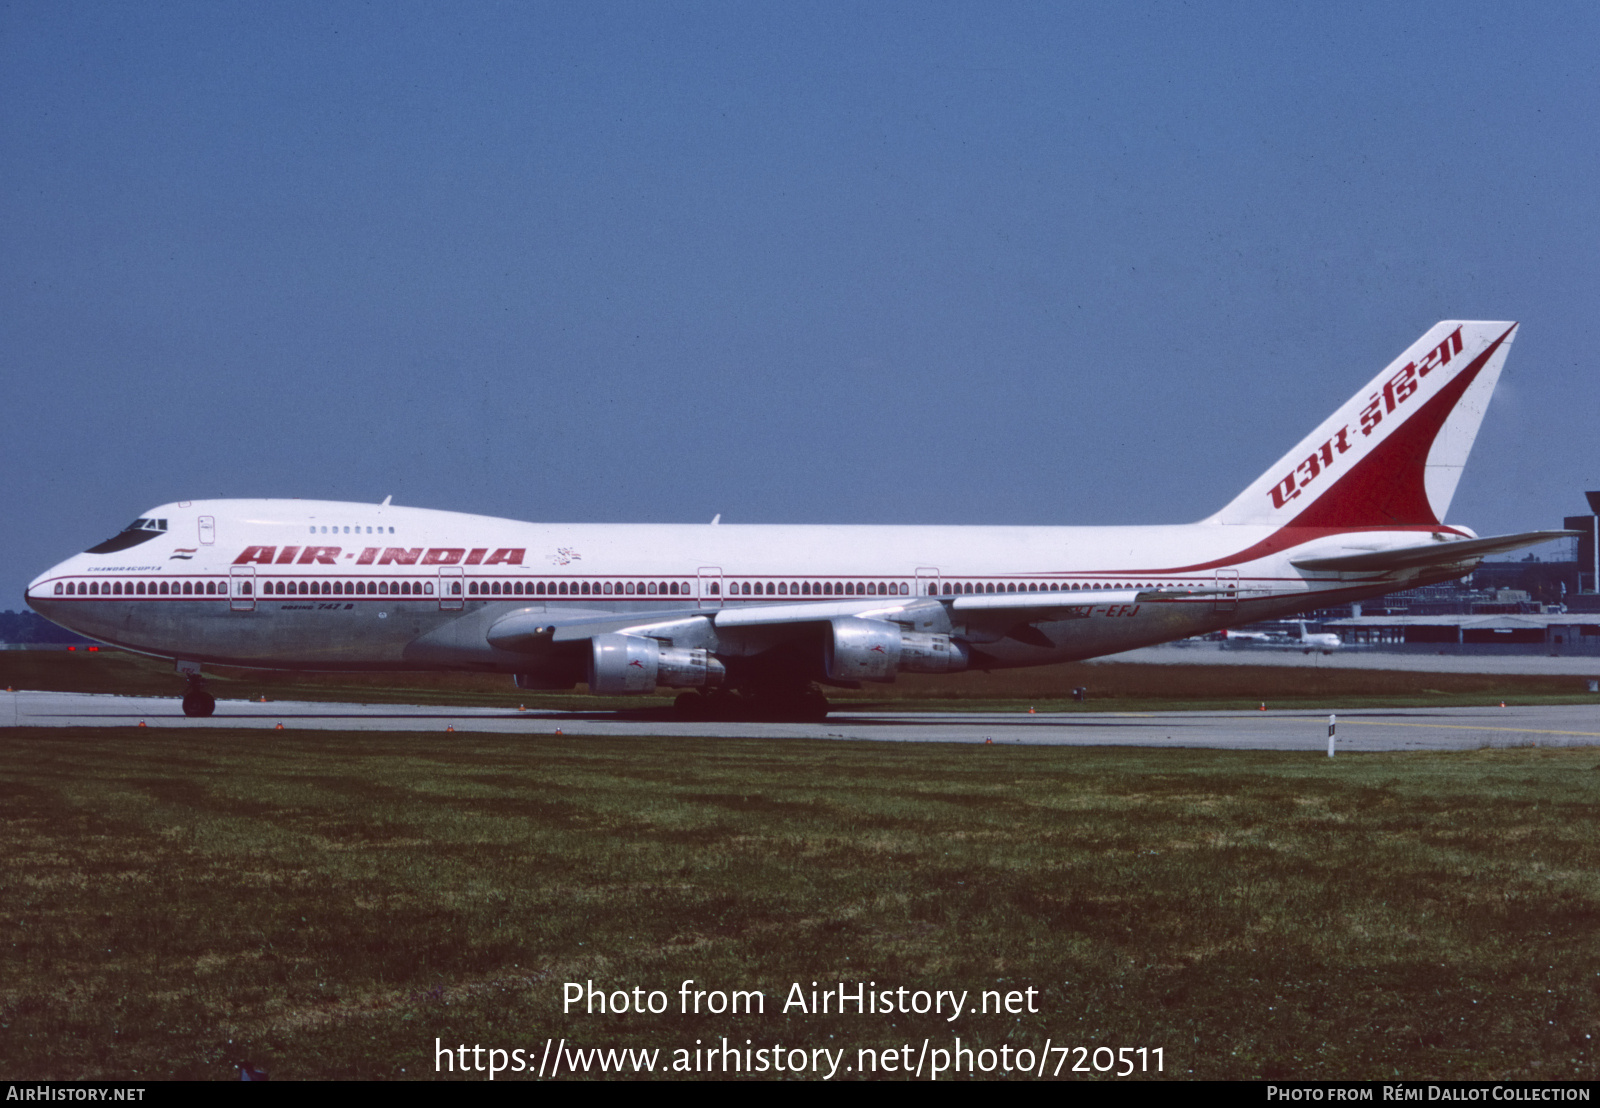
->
(0, 726), (1600, 1079)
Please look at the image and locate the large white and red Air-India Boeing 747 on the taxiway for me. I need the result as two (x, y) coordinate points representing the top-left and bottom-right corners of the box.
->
(27, 322), (1566, 719)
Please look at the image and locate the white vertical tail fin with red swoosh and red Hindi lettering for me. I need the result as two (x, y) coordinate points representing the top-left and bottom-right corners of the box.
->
(1205, 320), (1517, 528)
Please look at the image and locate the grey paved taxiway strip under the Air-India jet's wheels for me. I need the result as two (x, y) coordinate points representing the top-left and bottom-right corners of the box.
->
(12, 692), (1600, 753)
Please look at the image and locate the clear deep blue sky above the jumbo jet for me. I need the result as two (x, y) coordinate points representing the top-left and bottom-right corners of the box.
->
(0, 2), (1600, 607)
